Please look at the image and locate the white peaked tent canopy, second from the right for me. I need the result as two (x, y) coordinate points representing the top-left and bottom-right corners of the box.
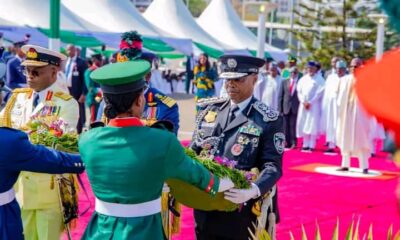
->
(143, 0), (232, 56)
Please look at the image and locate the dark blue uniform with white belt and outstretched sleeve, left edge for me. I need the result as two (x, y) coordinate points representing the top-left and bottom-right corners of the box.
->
(0, 128), (84, 240)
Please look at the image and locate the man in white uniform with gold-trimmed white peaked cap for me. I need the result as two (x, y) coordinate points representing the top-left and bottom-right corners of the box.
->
(0, 45), (79, 240)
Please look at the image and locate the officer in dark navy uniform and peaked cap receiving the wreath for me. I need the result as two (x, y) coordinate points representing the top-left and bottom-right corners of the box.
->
(191, 55), (285, 240)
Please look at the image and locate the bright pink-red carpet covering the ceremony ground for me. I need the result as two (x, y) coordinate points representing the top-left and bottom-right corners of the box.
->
(72, 142), (400, 240)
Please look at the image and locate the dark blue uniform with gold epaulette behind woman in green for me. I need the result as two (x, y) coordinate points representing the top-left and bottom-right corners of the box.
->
(143, 88), (179, 134)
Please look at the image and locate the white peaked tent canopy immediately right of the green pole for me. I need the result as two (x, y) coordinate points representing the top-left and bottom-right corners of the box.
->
(62, 0), (193, 55)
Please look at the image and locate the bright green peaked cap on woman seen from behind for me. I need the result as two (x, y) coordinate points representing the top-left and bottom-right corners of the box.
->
(90, 60), (151, 94)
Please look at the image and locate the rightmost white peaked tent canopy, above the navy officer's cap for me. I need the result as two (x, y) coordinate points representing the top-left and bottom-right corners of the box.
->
(197, 0), (287, 61)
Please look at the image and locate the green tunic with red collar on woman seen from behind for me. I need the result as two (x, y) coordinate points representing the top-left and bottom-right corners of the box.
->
(79, 118), (219, 240)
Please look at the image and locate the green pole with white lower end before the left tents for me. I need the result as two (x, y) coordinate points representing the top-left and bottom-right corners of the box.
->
(49, 0), (60, 52)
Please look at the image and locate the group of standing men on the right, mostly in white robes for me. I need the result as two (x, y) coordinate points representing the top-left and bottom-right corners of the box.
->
(236, 57), (385, 174)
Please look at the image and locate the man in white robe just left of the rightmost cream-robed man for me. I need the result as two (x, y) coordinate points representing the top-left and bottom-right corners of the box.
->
(321, 60), (347, 152)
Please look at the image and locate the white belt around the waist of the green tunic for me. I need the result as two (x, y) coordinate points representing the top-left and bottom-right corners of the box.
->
(95, 197), (161, 217)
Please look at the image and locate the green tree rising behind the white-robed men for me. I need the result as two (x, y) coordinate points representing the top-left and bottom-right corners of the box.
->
(292, 0), (376, 68)
